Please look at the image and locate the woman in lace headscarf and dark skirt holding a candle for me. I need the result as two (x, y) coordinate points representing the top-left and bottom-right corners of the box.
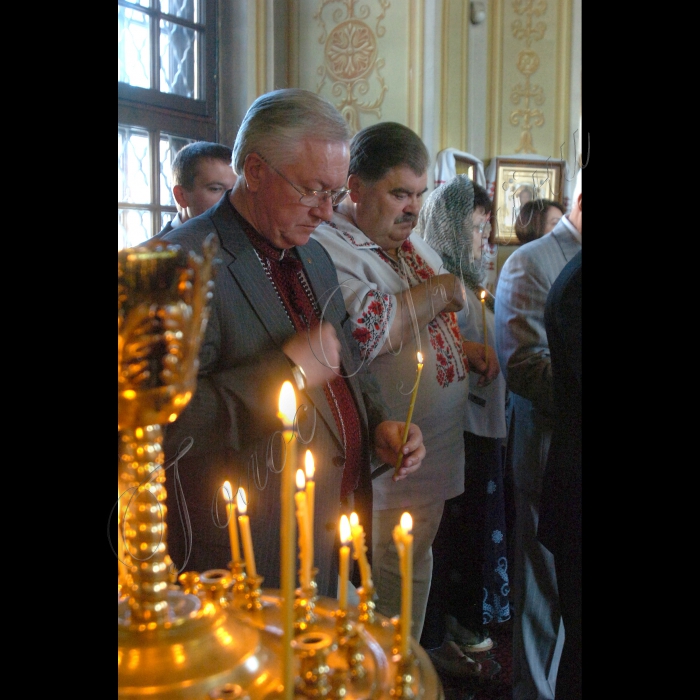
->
(416, 175), (510, 671)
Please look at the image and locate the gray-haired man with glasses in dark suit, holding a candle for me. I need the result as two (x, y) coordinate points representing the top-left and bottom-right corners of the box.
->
(156, 89), (425, 597)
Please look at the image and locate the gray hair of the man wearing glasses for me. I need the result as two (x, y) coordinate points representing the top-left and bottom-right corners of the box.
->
(233, 88), (352, 175)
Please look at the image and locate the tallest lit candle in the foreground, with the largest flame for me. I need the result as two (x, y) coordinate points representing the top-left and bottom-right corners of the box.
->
(277, 382), (297, 700)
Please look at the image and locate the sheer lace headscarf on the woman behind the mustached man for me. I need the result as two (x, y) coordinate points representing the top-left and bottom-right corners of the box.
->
(415, 174), (493, 305)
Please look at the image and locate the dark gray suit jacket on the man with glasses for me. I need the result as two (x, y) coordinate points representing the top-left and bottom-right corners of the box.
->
(161, 193), (386, 597)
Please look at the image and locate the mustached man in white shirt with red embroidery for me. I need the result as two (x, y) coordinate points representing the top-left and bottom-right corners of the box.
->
(312, 122), (498, 660)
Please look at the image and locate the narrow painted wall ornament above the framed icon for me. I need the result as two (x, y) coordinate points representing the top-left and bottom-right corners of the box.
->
(509, 0), (547, 153)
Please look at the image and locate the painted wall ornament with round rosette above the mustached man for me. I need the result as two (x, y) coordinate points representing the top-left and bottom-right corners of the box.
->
(313, 0), (391, 133)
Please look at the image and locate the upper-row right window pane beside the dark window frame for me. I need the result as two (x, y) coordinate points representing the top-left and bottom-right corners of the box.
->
(160, 20), (199, 100)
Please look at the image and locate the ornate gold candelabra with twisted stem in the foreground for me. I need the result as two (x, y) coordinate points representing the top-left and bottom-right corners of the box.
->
(117, 234), (444, 700)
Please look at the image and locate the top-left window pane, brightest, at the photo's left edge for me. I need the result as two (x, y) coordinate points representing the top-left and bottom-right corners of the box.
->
(117, 5), (151, 88)
